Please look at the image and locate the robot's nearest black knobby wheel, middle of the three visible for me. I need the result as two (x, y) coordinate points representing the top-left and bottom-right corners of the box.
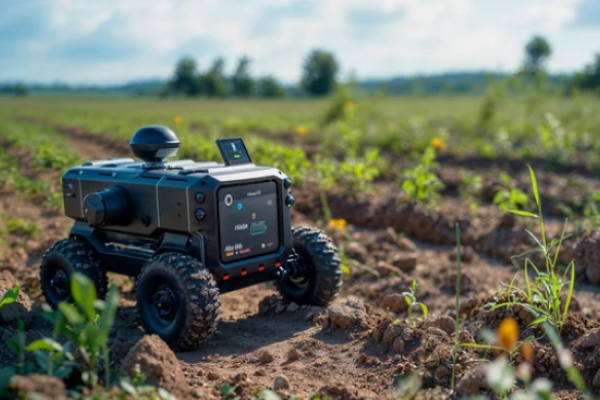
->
(136, 253), (220, 350)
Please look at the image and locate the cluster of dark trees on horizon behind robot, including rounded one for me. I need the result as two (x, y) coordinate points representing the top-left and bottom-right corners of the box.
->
(159, 50), (339, 98)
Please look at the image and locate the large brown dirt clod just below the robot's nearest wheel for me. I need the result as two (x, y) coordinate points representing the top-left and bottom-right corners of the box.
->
(121, 335), (189, 397)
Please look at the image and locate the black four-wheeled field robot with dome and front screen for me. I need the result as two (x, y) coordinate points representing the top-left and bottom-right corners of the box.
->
(40, 126), (342, 350)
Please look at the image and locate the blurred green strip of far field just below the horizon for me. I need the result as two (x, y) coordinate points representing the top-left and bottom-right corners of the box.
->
(0, 96), (600, 164)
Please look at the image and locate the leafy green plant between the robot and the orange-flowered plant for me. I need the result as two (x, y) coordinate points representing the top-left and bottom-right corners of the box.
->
(340, 148), (380, 195)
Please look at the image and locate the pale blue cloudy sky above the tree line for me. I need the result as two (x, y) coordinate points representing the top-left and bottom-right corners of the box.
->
(0, 0), (600, 84)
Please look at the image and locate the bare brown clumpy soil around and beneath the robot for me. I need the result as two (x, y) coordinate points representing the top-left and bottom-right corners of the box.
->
(0, 122), (600, 399)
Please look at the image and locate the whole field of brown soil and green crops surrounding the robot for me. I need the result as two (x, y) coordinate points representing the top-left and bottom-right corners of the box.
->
(0, 96), (600, 399)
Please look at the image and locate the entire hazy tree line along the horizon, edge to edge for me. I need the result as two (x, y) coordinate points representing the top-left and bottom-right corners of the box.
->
(0, 36), (600, 98)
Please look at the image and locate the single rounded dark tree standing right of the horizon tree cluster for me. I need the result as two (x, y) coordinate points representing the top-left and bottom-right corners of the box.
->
(301, 50), (339, 96)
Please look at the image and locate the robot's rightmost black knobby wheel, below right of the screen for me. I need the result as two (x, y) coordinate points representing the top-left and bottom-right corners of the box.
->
(275, 227), (342, 306)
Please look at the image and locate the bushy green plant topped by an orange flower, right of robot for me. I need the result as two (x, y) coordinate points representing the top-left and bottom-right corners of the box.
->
(401, 147), (444, 204)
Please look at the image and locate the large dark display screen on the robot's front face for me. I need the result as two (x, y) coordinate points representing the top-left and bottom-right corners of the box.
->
(219, 182), (279, 263)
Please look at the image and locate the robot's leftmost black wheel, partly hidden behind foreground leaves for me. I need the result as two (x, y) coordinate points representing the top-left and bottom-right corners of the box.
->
(40, 239), (108, 308)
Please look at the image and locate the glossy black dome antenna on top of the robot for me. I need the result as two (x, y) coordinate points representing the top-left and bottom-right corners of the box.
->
(129, 125), (180, 164)
